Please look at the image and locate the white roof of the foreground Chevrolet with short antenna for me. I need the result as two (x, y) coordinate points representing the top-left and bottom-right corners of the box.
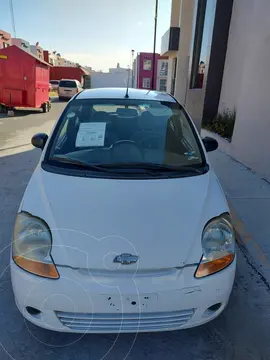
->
(76, 88), (176, 103)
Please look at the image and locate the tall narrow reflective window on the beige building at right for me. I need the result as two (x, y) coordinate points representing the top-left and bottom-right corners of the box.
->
(190, 0), (216, 89)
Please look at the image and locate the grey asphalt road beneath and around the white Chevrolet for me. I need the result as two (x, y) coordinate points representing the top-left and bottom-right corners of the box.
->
(0, 102), (270, 360)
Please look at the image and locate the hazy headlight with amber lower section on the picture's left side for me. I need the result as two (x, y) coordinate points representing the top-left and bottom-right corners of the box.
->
(12, 212), (59, 279)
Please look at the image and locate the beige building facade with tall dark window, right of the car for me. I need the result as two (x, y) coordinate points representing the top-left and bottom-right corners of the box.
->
(167, 0), (270, 181)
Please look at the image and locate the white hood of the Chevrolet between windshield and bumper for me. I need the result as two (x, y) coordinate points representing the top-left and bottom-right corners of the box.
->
(21, 166), (228, 270)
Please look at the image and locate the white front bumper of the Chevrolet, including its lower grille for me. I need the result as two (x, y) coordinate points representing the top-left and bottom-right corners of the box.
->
(11, 260), (236, 333)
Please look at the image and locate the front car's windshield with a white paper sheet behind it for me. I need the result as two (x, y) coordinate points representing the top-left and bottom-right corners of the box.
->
(45, 99), (205, 177)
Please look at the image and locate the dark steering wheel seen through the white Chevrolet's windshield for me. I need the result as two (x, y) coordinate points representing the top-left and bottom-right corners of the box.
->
(111, 140), (144, 162)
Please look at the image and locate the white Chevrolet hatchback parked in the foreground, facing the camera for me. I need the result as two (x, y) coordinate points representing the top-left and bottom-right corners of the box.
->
(10, 89), (236, 333)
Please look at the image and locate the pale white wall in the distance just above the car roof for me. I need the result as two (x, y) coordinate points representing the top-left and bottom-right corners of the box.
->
(91, 71), (131, 88)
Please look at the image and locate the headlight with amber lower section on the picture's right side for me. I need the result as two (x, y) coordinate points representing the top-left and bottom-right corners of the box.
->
(195, 214), (235, 278)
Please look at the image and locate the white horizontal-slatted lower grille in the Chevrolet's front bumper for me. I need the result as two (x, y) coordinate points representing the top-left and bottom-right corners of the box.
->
(55, 309), (195, 332)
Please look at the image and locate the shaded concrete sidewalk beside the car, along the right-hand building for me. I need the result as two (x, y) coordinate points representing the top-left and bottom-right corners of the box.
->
(202, 133), (270, 290)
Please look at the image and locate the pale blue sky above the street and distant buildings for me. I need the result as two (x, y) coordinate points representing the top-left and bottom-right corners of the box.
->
(0, 0), (172, 71)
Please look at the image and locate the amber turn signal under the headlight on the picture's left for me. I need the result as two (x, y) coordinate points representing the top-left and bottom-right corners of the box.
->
(13, 256), (59, 279)
